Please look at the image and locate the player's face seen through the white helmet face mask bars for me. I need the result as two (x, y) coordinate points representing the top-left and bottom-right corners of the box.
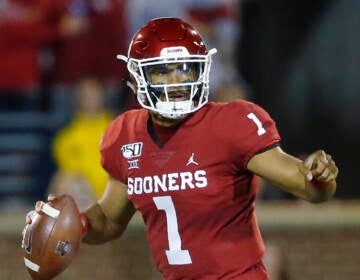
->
(145, 63), (199, 101)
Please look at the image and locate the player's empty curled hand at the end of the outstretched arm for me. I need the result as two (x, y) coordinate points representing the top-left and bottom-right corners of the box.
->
(300, 150), (339, 182)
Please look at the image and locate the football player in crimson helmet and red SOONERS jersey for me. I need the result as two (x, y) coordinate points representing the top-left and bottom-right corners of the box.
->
(28, 18), (338, 280)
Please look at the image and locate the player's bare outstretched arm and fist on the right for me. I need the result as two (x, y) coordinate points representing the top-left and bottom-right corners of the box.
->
(247, 147), (338, 203)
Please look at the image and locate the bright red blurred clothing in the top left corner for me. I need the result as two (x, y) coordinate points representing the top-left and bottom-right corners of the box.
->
(0, 0), (59, 91)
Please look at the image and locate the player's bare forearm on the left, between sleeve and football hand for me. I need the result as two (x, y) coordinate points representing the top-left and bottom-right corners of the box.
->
(83, 178), (135, 244)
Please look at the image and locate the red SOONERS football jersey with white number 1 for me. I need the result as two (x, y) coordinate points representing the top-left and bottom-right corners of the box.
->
(101, 101), (280, 280)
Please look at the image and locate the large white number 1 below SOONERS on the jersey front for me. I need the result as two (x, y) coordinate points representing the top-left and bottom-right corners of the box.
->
(153, 196), (192, 265)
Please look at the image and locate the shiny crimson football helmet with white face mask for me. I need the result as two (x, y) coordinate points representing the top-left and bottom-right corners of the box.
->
(117, 18), (216, 119)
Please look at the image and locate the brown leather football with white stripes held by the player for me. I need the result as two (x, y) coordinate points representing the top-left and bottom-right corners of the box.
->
(22, 195), (82, 280)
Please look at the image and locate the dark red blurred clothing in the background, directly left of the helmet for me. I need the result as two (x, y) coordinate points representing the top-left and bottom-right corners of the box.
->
(53, 0), (128, 84)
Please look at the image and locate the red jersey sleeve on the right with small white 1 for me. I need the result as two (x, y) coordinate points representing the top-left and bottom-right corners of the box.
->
(232, 101), (281, 169)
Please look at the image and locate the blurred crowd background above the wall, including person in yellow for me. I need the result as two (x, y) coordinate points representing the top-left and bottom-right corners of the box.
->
(0, 0), (360, 279)
